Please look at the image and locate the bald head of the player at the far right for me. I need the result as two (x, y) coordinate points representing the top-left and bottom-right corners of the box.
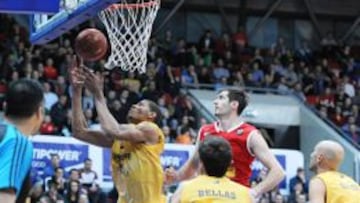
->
(315, 140), (344, 169)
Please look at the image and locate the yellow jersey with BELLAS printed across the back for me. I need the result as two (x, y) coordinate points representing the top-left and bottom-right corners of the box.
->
(180, 175), (251, 203)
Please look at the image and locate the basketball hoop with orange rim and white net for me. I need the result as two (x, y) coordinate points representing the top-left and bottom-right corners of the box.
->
(99, 0), (160, 73)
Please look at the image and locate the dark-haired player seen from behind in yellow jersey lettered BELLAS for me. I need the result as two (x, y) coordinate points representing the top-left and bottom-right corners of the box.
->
(172, 136), (254, 203)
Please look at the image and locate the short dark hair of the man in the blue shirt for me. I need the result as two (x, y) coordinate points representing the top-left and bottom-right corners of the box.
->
(5, 79), (44, 119)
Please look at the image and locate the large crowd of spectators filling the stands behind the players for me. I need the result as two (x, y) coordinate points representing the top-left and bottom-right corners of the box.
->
(0, 15), (360, 202)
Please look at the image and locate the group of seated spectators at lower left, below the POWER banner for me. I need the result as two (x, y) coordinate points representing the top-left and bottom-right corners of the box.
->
(29, 154), (112, 203)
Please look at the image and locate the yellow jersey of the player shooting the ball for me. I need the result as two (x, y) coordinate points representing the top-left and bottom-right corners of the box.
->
(111, 122), (165, 203)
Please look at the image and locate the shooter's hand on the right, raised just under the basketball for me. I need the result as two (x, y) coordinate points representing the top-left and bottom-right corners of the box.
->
(83, 67), (104, 97)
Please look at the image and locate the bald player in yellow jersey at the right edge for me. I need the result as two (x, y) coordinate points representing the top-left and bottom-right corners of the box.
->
(309, 140), (360, 203)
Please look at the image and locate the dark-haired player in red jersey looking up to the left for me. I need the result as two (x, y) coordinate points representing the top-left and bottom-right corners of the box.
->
(165, 89), (284, 198)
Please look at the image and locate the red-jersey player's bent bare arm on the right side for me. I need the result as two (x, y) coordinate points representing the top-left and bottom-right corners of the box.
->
(248, 130), (285, 196)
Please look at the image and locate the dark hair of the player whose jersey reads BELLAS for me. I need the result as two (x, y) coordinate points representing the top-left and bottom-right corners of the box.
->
(199, 136), (232, 177)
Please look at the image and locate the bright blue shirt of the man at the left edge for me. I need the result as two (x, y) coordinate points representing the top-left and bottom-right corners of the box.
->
(0, 123), (33, 196)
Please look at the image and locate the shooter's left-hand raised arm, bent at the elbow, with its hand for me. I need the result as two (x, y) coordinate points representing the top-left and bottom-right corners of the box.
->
(70, 57), (113, 148)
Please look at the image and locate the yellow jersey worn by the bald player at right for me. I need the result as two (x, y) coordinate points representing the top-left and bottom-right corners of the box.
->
(315, 171), (360, 203)
